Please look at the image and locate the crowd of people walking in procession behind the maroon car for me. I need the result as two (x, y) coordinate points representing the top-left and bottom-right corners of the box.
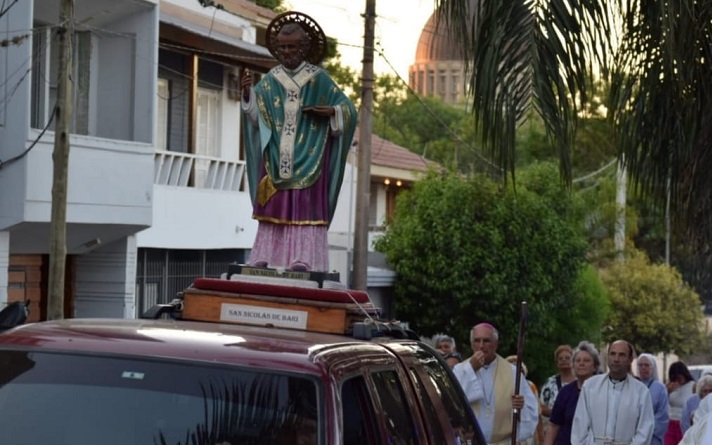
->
(433, 323), (712, 445)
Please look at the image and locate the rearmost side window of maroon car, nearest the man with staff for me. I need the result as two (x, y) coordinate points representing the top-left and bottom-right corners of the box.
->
(413, 345), (486, 445)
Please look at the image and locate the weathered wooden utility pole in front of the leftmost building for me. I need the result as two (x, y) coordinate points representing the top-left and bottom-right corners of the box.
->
(47, 0), (74, 320)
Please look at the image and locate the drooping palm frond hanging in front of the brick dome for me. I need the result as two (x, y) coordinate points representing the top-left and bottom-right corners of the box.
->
(436, 0), (610, 183)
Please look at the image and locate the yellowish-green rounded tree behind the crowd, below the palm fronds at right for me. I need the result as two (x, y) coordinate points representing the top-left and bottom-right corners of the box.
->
(602, 248), (702, 354)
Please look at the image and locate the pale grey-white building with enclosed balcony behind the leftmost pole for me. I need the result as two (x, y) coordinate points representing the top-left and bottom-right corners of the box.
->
(0, 0), (158, 319)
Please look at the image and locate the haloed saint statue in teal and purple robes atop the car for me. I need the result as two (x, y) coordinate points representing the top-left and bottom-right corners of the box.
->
(241, 11), (357, 271)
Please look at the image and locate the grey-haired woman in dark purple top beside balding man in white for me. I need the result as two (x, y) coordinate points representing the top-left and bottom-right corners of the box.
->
(544, 341), (601, 445)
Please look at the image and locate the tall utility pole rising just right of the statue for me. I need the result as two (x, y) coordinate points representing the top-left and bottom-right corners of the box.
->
(351, 0), (376, 291)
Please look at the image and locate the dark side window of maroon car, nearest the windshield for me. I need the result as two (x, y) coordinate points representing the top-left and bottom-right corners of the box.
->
(341, 377), (381, 445)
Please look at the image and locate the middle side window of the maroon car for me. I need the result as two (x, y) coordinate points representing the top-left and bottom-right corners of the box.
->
(371, 371), (418, 445)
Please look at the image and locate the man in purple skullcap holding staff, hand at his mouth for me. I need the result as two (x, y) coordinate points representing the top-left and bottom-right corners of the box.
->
(452, 323), (536, 445)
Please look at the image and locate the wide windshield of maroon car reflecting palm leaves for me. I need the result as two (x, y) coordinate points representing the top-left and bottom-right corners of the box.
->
(0, 351), (321, 445)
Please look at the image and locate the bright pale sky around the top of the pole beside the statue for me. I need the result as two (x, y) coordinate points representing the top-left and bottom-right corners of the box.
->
(284, 0), (435, 81)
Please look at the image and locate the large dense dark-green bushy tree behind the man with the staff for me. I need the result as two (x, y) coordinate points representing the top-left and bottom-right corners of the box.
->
(376, 165), (606, 377)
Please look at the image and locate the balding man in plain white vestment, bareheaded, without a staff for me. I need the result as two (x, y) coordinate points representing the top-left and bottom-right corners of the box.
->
(571, 340), (655, 445)
